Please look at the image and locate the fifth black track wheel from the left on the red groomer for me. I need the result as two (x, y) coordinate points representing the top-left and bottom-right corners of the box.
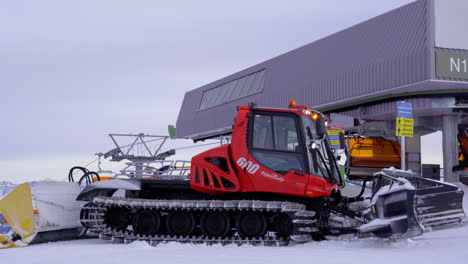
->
(236, 212), (267, 237)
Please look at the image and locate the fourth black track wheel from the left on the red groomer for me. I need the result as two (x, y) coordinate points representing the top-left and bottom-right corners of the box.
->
(200, 212), (231, 237)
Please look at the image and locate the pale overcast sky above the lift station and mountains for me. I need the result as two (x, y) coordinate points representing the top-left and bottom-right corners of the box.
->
(0, 0), (442, 181)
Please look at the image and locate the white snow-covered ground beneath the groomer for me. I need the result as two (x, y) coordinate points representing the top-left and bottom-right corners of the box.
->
(0, 186), (468, 264)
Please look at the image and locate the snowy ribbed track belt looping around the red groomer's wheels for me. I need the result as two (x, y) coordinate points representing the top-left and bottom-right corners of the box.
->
(80, 197), (318, 246)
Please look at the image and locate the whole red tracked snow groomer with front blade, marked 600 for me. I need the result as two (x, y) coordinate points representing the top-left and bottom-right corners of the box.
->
(73, 104), (466, 245)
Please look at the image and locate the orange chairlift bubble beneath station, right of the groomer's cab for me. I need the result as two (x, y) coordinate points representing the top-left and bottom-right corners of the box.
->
(347, 137), (401, 168)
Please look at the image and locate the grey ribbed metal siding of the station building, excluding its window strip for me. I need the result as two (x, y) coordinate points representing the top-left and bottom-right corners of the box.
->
(177, 0), (430, 137)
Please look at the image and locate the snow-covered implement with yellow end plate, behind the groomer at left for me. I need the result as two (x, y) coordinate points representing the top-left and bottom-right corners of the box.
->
(0, 181), (88, 248)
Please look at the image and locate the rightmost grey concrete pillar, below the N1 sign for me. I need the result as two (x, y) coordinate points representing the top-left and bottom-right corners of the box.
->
(442, 116), (458, 182)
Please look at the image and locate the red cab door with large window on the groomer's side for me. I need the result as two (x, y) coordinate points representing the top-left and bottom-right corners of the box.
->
(246, 111), (309, 196)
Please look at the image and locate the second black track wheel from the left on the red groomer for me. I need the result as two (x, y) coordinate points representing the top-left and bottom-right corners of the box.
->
(132, 210), (161, 235)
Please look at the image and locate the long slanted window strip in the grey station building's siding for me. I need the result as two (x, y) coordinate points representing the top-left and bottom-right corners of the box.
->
(199, 70), (265, 110)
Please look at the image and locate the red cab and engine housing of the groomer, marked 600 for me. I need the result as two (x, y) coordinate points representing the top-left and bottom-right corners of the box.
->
(185, 103), (341, 200)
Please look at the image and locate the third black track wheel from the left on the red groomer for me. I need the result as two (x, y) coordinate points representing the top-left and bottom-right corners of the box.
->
(166, 211), (195, 236)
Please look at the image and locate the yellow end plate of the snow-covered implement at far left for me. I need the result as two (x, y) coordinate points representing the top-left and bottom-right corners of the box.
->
(0, 183), (36, 248)
